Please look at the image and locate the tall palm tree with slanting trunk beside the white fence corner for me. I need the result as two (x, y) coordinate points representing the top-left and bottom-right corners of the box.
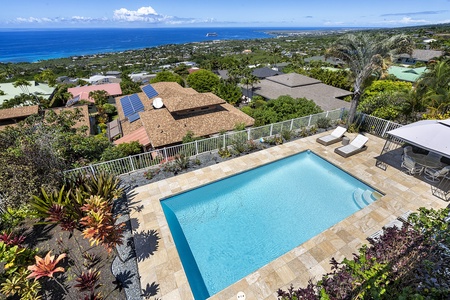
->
(327, 33), (413, 125)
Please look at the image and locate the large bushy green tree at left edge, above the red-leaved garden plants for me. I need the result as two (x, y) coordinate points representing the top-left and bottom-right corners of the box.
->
(0, 110), (111, 207)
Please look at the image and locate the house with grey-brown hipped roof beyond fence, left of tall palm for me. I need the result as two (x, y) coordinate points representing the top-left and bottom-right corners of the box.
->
(246, 73), (353, 111)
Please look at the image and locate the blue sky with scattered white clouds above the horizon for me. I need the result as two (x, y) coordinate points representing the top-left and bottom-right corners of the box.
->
(0, 0), (450, 28)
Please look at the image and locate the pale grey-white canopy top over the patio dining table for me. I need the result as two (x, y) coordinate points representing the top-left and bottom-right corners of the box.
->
(387, 119), (450, 157)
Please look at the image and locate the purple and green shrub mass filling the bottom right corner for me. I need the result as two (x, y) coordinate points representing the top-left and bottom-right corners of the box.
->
(278, 208), (450, 299)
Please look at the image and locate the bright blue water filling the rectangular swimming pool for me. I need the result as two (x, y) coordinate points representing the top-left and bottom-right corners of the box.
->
(161, 151), (373, 299)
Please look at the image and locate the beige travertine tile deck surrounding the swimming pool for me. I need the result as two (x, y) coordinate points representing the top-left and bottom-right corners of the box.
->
(128, 133), (448, 300)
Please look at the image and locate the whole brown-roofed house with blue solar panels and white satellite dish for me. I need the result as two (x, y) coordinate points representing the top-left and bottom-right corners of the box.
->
(111, 82), (254, 150)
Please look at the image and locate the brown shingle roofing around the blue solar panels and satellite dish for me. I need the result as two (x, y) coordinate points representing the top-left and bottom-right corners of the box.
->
(116, 82), (254, 147)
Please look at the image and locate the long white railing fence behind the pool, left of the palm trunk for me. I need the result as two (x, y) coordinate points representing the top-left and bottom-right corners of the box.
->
(65, 109), (344, 175)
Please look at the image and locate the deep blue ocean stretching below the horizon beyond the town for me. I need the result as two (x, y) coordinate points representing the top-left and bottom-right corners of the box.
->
(0, 28), (346, 63)
